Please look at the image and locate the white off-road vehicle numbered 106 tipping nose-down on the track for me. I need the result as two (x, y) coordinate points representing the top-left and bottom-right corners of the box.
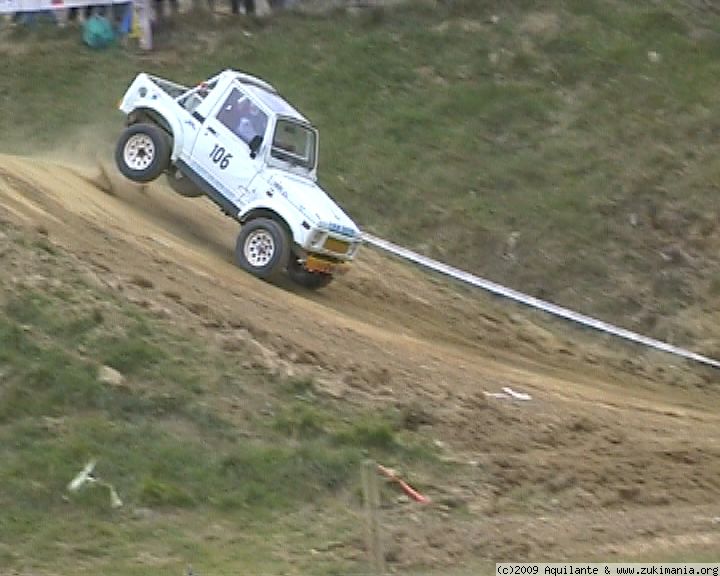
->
(115, 70), (362, 288)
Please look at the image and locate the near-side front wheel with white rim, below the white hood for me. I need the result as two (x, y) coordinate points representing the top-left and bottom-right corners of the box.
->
(235, 218), (290, 280)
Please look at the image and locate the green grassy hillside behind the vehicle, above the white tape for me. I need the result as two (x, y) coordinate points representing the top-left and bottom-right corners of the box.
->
(0, 0), (720, 344)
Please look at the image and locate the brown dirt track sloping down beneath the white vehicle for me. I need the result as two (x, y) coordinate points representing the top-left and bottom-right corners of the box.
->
(0, 156), (720, 564)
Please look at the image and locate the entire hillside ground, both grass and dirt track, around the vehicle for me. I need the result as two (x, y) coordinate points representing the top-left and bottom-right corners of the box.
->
(0, 0), (720, 576)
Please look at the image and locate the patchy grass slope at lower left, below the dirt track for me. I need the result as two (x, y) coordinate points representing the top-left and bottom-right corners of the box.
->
(0, 227), (436, 574)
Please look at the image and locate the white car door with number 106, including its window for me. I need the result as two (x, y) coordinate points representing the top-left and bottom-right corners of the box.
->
(192, 86), (268, 207)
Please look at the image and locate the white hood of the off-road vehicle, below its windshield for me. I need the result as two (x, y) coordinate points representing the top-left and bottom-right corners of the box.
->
(265, 170), (360, 236)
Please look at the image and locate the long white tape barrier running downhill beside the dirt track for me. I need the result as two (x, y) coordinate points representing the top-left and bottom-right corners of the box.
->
(363, 233), (720, 369)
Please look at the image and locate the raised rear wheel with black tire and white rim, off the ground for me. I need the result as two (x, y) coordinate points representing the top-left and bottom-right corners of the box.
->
(115, 123), (170, 182)
